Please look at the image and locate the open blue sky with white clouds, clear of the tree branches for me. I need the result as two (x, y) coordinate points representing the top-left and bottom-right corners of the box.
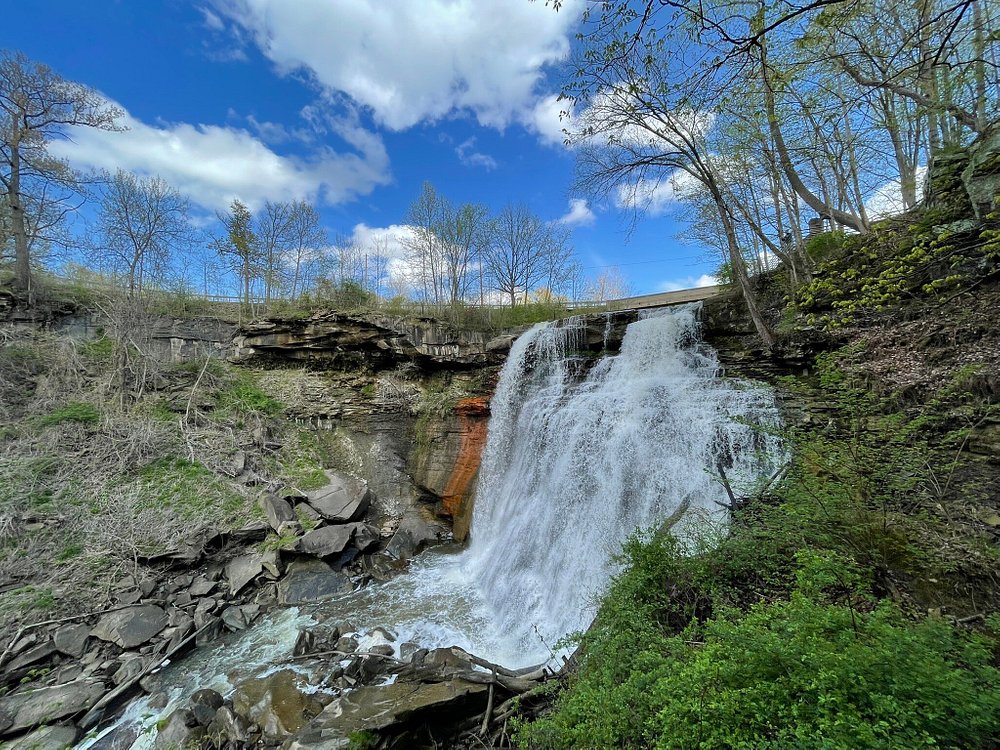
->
(0, 0), (717, 293)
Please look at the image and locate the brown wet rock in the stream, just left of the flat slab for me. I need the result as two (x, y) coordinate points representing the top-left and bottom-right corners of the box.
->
(233, 670), (323, 739)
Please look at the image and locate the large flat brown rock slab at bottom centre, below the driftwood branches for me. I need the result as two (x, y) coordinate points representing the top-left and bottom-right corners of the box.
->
(286, 680), (488, 750)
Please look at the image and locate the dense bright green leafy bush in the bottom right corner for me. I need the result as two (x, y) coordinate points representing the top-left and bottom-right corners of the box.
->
(518, 539), (1000, 750)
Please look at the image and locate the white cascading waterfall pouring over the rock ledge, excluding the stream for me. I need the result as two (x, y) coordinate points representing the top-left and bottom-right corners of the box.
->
(463, 306), (782, 653)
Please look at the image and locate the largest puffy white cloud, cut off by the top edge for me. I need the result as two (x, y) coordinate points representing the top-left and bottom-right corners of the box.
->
(213, 0), (583, 130)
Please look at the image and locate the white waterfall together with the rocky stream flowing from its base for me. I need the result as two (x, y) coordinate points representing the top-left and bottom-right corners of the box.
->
(79, 305), (785, 748)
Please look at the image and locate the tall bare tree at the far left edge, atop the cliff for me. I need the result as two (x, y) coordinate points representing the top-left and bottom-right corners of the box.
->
(0, 51), (124, 297)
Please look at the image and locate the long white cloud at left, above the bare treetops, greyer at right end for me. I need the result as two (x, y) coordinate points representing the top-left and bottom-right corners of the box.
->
(50, 104), (389, 209)
